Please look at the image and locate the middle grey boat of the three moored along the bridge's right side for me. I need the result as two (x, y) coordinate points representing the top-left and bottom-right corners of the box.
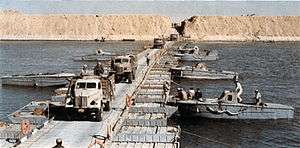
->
(170, 63), (238, 80)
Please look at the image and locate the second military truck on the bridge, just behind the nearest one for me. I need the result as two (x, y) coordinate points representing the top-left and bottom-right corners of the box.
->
(111, 55), (137, 83)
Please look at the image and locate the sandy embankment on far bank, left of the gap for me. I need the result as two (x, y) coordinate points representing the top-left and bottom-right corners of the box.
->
(0, 11), (171, 40)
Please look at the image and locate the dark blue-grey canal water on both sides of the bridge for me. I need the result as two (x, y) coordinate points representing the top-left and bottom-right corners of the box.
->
(0, 41), (300, 147)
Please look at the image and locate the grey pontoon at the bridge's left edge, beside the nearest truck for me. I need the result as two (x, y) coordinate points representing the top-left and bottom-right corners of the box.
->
(8, 101), (48, 125)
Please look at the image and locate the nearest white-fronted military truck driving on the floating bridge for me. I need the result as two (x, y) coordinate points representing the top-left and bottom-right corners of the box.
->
(60, 75), (115, 121)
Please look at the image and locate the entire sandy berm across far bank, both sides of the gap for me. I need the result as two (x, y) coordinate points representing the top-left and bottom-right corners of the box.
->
(0, 10), (300, 41)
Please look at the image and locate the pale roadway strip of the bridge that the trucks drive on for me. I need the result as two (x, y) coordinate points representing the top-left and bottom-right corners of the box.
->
(18, 49), (160, 148)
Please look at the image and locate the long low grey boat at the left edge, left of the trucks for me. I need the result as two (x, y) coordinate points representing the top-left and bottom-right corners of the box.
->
(1, 73), (75, 87)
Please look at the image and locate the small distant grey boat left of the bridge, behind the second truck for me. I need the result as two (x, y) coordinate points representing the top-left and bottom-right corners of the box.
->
(73, 49), (117, 62)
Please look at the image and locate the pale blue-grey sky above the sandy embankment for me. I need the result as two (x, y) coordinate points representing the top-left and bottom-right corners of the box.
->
(0, 0), (300, 22)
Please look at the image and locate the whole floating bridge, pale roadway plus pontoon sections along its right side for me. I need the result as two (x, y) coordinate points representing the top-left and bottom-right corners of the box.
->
(0, 43), (180, 148)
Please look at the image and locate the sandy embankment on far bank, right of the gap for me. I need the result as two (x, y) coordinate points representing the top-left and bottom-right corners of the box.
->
(181, 16), (300, 41)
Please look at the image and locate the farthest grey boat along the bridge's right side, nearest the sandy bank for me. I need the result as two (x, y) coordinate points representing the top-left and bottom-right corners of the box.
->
(174, 46), (219, 62)
